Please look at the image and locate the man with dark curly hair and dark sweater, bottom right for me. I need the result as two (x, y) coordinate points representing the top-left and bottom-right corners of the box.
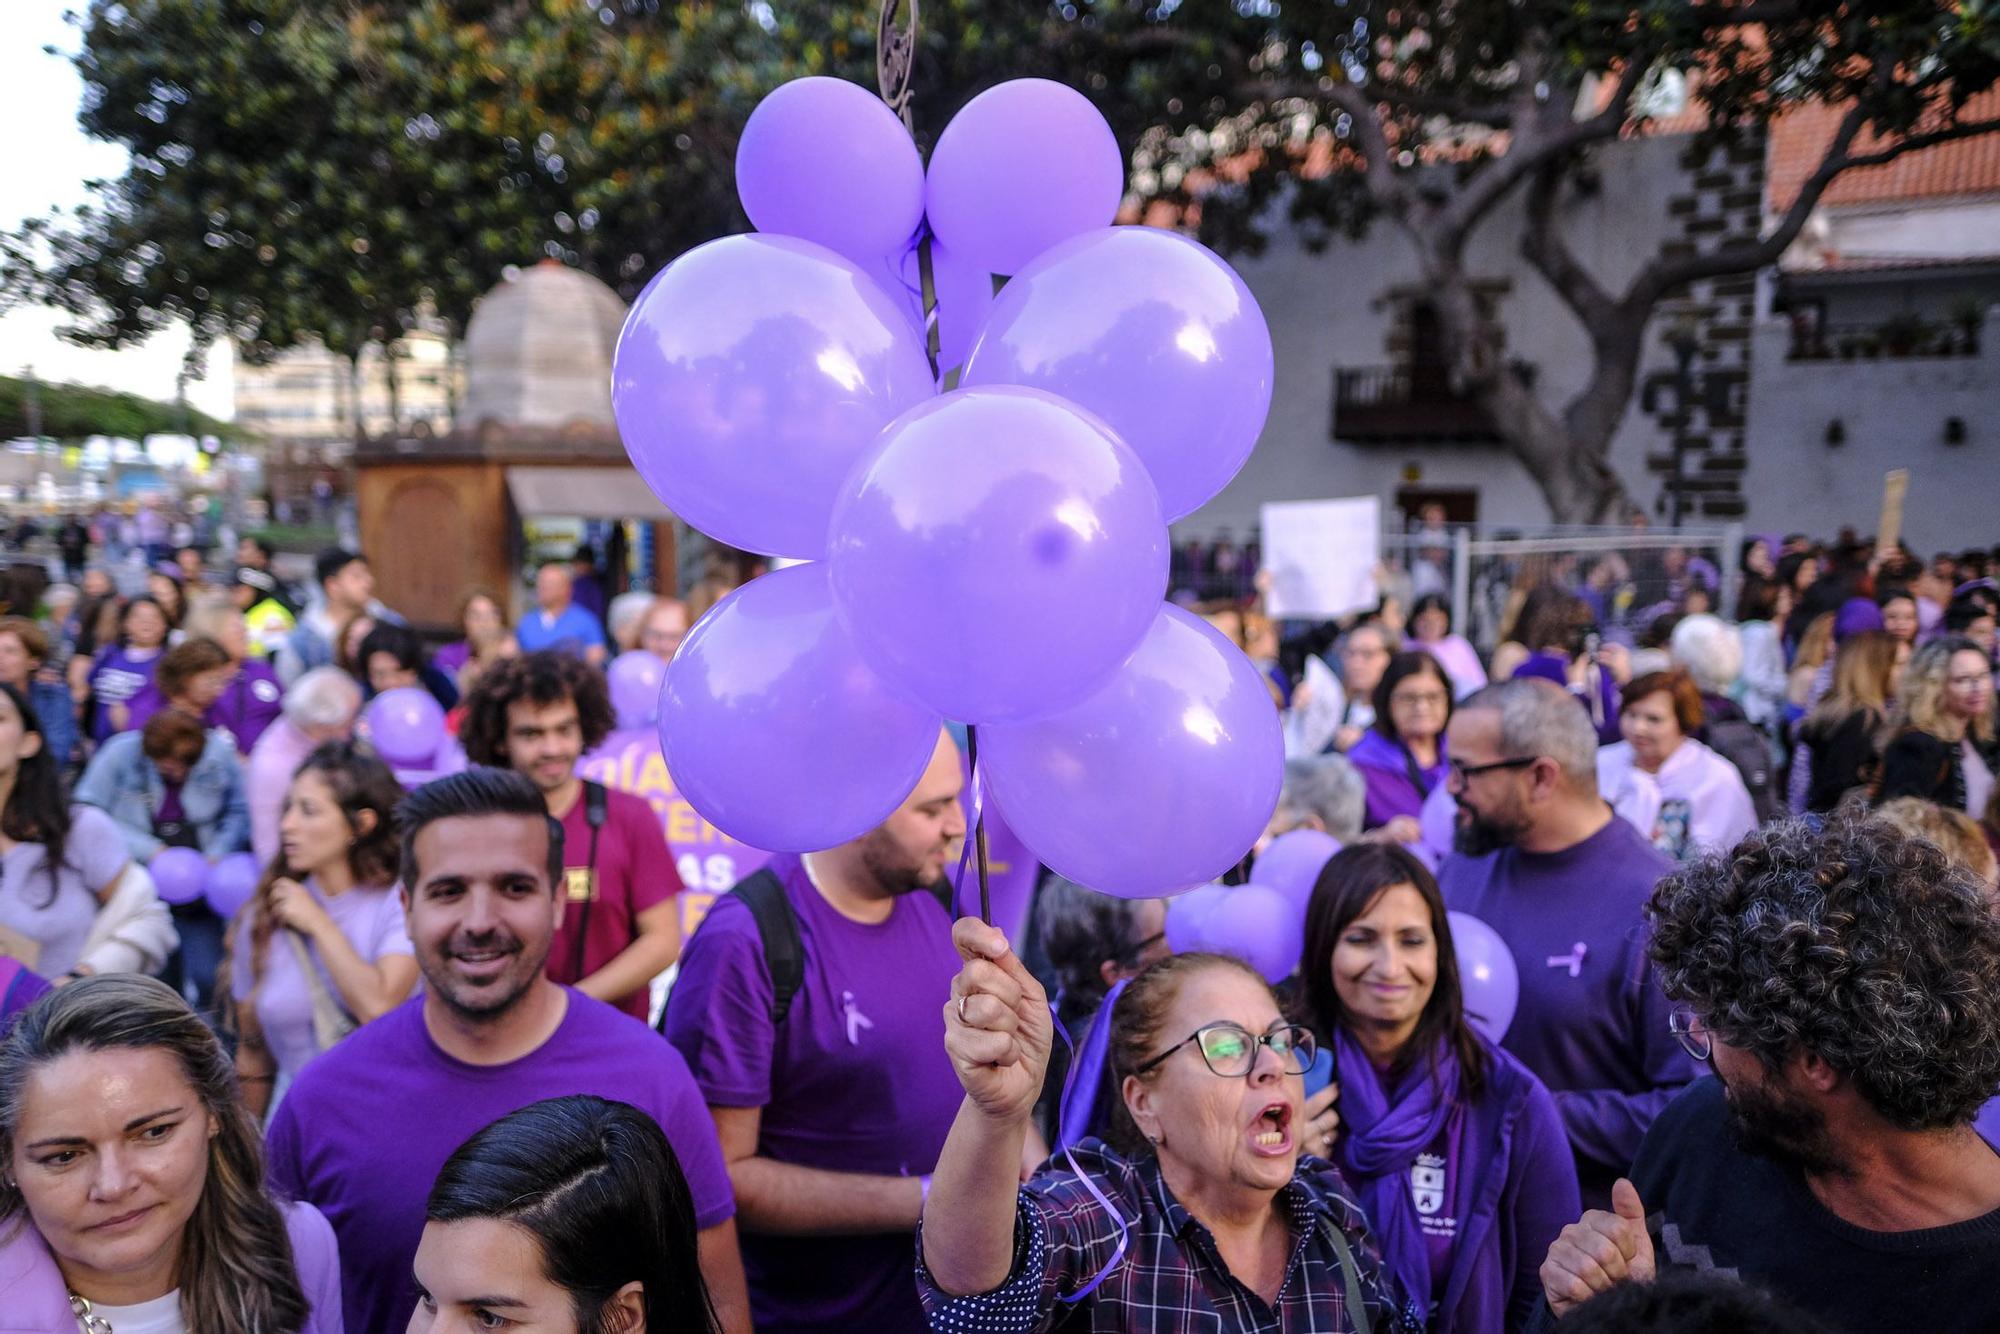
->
(1530, 820), (2000, 1334)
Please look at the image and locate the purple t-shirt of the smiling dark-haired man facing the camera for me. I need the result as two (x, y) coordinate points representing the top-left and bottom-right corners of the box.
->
(266, 990), (736, 1334)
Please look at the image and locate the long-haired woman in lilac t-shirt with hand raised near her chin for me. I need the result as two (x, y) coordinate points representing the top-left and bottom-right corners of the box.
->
(230, 742), (416, 1116)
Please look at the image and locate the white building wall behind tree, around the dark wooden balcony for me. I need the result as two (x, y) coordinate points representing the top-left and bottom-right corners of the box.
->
(1176, 136), (1712, 536)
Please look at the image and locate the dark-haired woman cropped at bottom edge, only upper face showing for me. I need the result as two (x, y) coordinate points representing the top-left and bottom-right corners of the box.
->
(410, 1094), (718, 1334)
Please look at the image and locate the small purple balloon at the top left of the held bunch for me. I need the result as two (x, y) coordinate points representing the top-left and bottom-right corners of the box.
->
(736, 76), (924, 264)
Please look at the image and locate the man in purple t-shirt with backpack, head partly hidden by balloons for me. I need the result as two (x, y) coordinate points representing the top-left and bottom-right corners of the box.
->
(666, 736), (966, 1334)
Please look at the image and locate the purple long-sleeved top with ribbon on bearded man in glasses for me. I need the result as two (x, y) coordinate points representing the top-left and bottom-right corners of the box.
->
(1438, 816), (1698, 1208)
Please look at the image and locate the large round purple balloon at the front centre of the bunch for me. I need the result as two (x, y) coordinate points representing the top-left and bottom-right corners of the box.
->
(826, 386), (1168, 724)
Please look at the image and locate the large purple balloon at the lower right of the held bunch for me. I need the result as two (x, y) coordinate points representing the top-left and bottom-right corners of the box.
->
(980, 606), (1284, 898)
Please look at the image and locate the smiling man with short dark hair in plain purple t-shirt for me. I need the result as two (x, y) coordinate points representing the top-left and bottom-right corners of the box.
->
(268, 768), (752, 1334)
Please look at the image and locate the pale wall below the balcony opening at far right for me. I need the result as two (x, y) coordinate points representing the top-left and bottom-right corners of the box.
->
(1744, 310), (2000, 554)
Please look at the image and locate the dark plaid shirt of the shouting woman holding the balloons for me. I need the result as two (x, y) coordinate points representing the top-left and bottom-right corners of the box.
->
(916, 1140), (1424, 1334)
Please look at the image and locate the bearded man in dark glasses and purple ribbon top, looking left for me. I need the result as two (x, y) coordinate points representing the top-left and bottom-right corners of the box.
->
(1438, 678), (1696, 1204)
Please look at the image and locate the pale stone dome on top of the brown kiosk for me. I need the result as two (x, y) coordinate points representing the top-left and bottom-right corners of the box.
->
(458, 260), (626, 432)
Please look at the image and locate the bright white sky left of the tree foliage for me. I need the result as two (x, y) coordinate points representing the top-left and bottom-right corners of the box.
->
(0, 0), (234, 418)
